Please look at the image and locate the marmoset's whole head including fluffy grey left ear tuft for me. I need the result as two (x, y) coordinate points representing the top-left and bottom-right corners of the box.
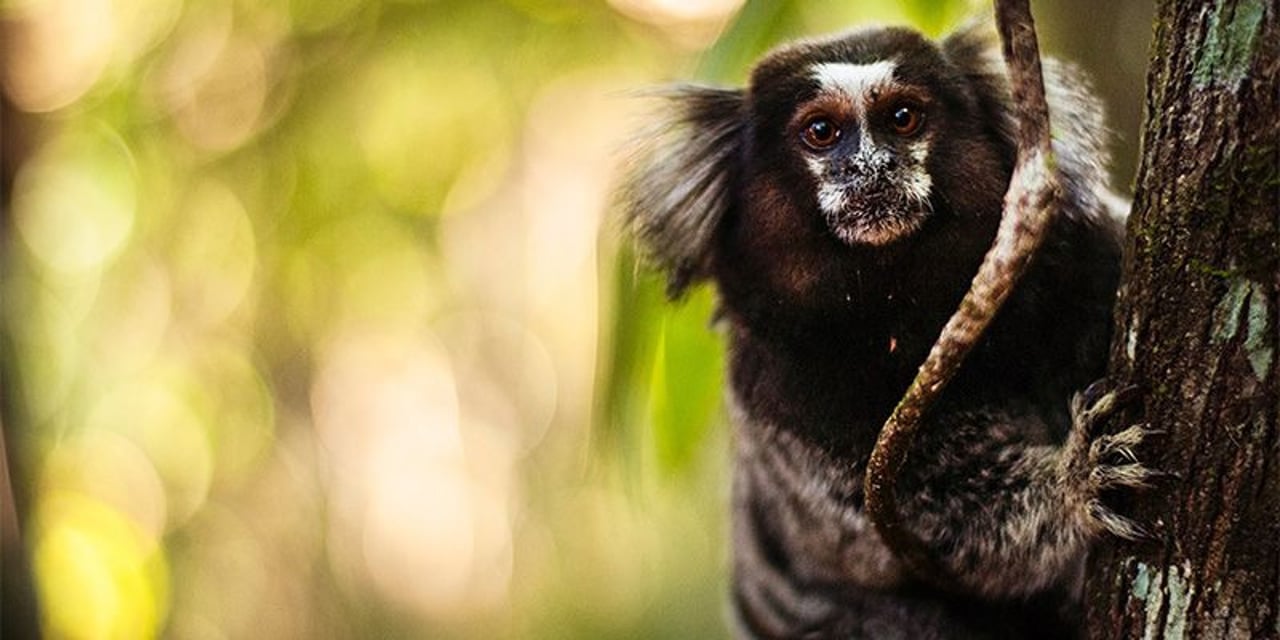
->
(626, 28), (1014, 322)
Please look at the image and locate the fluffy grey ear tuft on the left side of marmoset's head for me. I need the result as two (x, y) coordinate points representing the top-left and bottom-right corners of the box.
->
(621, 86), (746, 298)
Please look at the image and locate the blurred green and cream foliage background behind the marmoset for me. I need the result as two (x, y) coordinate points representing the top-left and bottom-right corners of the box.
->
(0, 0), (1151, 640)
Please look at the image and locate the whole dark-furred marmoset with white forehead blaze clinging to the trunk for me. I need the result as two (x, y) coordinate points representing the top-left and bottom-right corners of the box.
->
(622, 24), (1152, 640)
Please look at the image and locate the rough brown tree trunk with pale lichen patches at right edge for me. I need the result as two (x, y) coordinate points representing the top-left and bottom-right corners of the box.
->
(1085, 0), (1280, 640)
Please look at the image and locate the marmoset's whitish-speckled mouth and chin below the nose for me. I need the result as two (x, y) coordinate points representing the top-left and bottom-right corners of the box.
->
(819, 189), (928, 246)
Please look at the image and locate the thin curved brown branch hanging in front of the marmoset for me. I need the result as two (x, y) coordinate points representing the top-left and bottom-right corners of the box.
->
(864, 0), (1061, 586)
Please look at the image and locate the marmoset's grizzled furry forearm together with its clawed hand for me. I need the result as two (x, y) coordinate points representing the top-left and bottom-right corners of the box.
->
(902, 385), (1158, 599)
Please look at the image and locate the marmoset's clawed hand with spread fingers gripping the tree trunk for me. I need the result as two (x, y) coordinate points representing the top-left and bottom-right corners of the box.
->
(1059, 380), (1161, 540)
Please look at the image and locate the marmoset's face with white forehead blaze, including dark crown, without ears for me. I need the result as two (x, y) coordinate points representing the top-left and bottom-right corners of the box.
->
(751, 29), (946, 246)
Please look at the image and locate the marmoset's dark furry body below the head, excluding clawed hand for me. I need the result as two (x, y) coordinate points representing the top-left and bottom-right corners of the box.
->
(726, 198), (1119, 639)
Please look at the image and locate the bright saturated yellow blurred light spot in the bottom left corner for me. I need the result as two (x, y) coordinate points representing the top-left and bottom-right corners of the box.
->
(35, 493), (168, 640)
